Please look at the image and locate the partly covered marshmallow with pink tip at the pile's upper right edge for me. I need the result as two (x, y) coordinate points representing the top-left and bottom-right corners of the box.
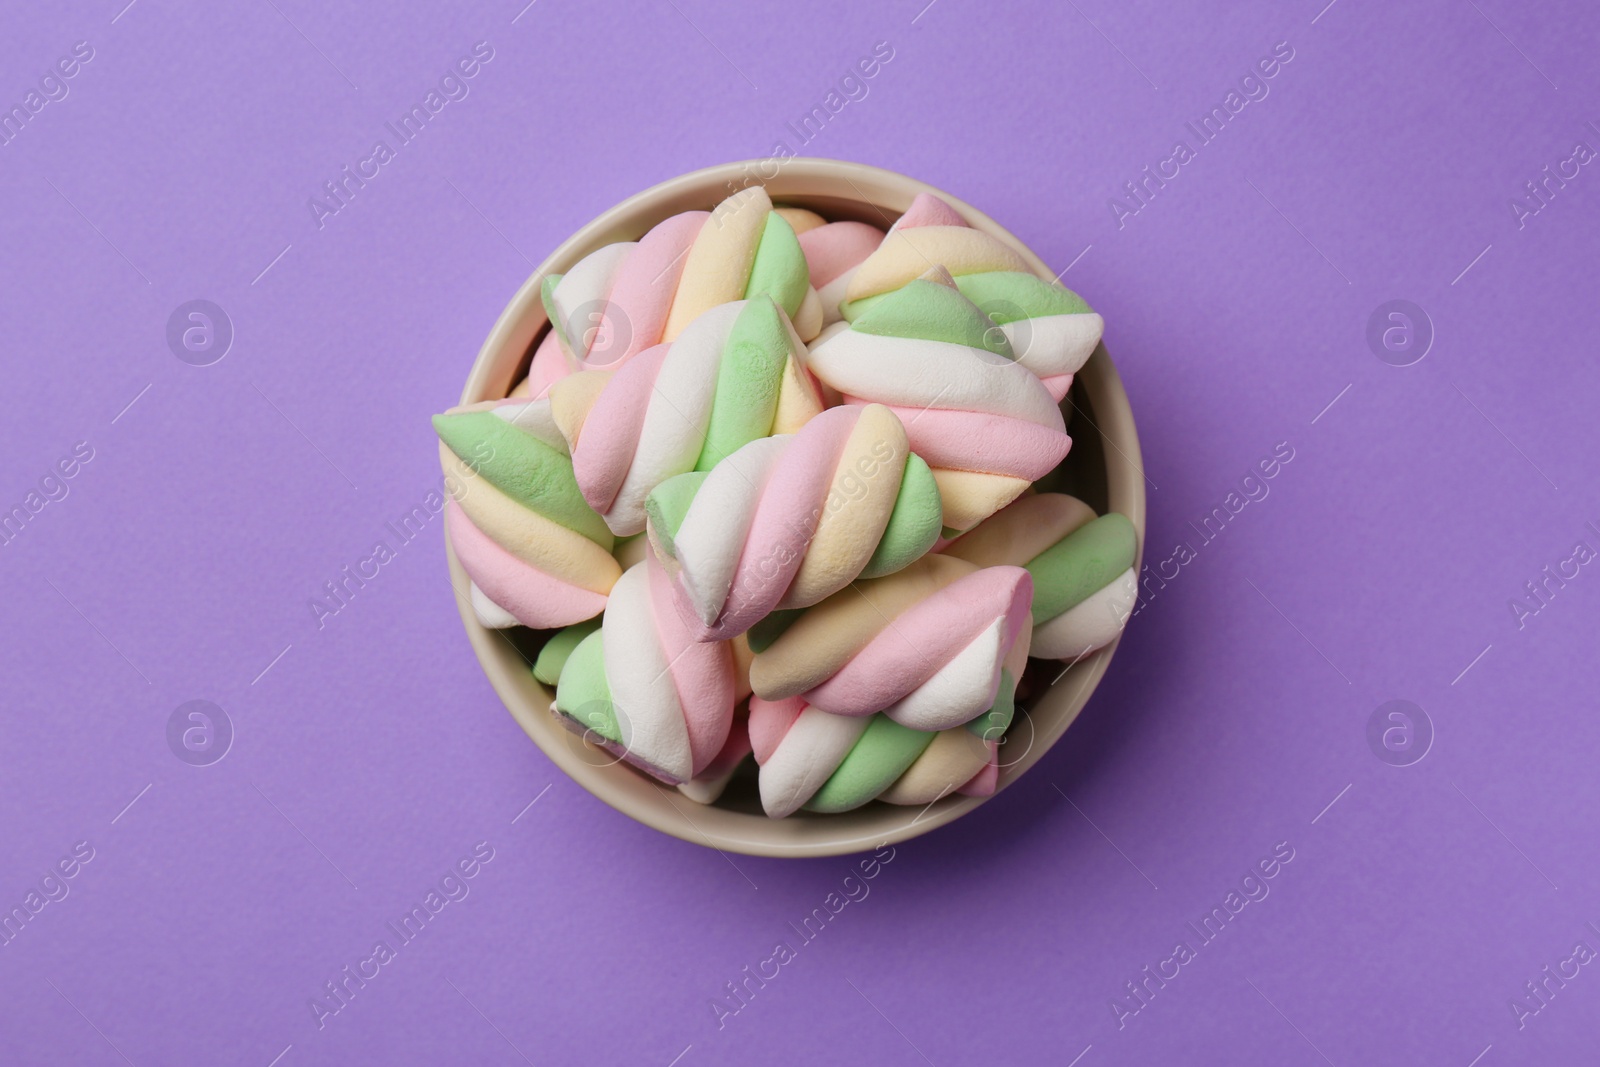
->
(840, 194), (1106, 402)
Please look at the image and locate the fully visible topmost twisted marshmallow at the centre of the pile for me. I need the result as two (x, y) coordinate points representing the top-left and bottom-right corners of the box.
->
(646, 405), (942, 638)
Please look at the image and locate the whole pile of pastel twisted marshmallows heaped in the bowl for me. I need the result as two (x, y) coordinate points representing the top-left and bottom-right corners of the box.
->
(434, 187), (1138, 817)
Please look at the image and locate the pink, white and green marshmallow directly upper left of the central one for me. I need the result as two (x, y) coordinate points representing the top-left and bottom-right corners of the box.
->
(550, 296), (822, 536)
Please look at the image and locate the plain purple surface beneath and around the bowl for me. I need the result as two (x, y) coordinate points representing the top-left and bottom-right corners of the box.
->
(0, 0), (1600, 1067)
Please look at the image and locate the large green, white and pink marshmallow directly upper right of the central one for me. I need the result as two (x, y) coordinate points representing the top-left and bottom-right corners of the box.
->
(810, 264), (1072, 531)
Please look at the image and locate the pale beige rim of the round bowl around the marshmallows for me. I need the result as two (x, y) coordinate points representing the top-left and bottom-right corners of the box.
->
(445, 157), (1146, 857)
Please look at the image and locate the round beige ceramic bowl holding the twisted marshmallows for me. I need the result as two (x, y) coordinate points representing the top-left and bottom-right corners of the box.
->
(446, 158), (1144, 856)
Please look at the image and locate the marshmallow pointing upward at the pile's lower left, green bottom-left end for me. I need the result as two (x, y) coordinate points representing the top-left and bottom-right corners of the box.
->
(553, 560), (742, 785)
